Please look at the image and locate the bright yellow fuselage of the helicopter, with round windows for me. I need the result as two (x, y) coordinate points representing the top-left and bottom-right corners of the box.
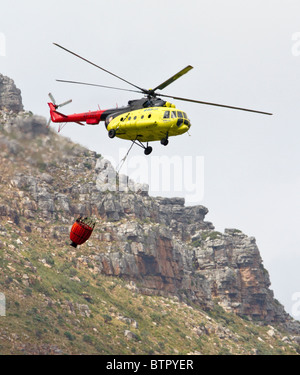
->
(106, 103), (191, 142)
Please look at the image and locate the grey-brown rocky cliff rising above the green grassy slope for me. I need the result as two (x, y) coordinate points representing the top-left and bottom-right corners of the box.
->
(0, 76), (300, 338)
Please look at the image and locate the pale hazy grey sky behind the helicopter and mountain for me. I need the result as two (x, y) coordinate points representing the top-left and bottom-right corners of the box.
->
(0, 0), (300, 319)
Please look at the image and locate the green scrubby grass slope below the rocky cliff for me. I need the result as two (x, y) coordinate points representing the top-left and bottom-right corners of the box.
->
(0, 224), (297, 355)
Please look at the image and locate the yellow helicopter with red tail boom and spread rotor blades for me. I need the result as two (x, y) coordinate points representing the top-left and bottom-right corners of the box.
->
(48, 43), (272, 155)
